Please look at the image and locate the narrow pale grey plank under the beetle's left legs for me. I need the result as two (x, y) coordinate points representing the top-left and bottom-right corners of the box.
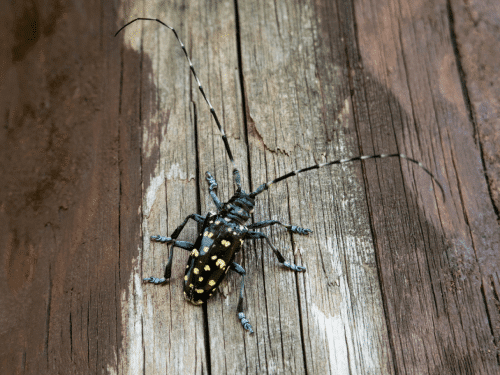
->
(116, 3), (207, 374)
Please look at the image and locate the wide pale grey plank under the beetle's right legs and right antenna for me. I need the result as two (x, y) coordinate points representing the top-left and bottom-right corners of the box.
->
(240, 2), (393, 374)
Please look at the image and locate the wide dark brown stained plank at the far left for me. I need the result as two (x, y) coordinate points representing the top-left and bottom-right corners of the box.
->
(0, 1), (126, 374)
